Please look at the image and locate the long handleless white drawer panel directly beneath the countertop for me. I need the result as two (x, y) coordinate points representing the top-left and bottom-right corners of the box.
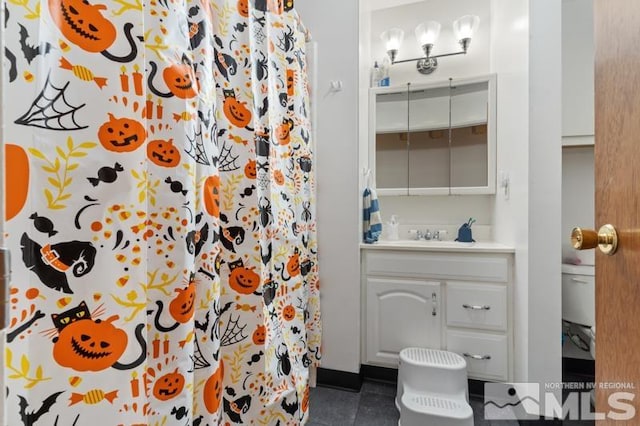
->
(365, 251), (509, 282)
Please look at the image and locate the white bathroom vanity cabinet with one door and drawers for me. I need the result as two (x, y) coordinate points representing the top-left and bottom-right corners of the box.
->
(362, 244), (513, 381)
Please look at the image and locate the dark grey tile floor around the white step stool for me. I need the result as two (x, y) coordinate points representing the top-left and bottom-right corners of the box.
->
(307, 379), (594, 426)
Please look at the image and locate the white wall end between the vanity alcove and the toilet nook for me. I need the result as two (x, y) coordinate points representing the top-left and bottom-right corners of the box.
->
(528, 0), (562, 398)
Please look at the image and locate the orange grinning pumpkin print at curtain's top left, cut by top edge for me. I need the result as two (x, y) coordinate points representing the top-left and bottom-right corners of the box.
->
(48, 0), (116, 53)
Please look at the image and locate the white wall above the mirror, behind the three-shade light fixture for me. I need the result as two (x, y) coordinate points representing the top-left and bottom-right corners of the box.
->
(369, 0), (491, 86)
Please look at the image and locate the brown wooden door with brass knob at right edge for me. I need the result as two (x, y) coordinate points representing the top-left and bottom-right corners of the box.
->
(594, 0), (640, 425)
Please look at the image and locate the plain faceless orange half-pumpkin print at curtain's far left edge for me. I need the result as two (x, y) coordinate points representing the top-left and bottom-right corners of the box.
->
(4, 143), (29, 220)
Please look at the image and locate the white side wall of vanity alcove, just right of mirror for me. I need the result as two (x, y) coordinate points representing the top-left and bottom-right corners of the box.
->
(491, 0), (529, 382)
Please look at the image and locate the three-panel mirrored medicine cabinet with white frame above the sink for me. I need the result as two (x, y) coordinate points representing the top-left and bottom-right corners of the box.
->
(369, 75), (496, 195)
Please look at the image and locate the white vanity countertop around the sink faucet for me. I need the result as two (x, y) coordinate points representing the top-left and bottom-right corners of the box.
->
(360, 240), (515, 253)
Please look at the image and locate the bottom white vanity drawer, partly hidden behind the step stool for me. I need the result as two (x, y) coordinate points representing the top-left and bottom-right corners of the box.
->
(447, 330), (509, 380)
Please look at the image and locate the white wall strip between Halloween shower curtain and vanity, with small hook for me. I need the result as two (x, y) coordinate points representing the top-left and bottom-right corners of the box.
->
(296, 0), (360, 373)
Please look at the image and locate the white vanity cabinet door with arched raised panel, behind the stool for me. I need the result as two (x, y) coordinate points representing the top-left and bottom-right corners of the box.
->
(366, 277), (442, 368)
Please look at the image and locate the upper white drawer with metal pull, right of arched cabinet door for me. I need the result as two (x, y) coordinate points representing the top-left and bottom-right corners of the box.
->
(446, 281), (507, 331)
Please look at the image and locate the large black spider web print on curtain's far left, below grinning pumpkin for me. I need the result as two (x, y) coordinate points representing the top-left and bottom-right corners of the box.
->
(15, 74), (88, 131)
